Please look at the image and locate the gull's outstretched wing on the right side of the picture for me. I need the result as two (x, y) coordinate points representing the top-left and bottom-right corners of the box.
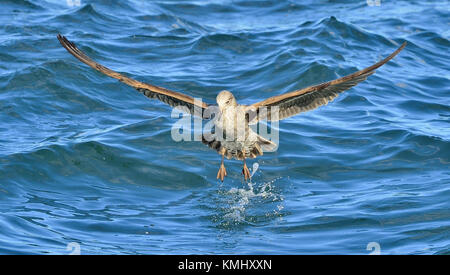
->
(247, 42), (406, 123)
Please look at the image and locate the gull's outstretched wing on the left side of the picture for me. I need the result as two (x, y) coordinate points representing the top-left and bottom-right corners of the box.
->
(58, 34), (208, 116)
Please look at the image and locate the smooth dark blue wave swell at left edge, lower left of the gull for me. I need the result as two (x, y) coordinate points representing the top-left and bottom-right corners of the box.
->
(1, 141), (206, 190)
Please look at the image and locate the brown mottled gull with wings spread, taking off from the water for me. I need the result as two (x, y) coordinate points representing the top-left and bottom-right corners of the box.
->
(58, 34), (406, 181)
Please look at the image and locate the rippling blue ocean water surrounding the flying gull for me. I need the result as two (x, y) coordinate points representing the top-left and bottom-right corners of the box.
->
(0, 0), (450, 254)
